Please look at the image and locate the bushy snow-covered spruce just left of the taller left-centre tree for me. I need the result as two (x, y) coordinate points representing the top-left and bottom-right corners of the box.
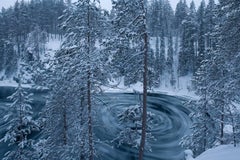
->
(42, 62), (86, 159)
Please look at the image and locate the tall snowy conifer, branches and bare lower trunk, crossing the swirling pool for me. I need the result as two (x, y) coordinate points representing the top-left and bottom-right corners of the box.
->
(109, 0), (149, 160)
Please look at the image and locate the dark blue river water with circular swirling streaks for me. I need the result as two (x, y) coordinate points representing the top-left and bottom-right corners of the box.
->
(0, 88), (191, 160)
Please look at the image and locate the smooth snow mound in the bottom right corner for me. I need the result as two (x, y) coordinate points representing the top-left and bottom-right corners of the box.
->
(194, 145), (240, 160)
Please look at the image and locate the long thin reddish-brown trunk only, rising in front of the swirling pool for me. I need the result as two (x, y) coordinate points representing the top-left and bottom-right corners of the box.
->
(138, 0), (148, 160)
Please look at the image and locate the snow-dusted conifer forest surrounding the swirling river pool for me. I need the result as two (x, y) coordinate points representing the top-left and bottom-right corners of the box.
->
(0, 0), (240, 160)
